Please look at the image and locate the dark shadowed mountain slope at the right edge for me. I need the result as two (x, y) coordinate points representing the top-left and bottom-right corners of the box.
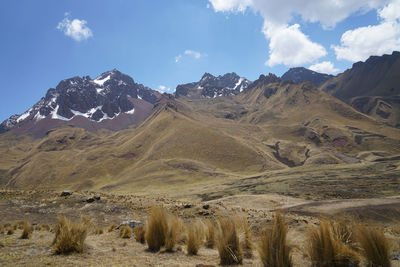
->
(321, 52), (400, 127)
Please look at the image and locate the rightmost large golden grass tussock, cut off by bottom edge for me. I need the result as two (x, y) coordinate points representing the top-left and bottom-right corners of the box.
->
(357, 226), (391, 267)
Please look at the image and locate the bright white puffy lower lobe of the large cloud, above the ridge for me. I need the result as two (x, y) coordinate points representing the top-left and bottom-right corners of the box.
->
(265, 24), (326, 66)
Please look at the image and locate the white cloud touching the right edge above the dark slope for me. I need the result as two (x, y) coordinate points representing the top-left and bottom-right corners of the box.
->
(332, 0), (400, 62)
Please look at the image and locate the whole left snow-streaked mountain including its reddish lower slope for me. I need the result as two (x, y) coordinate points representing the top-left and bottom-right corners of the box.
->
(0, 69), (160, 136)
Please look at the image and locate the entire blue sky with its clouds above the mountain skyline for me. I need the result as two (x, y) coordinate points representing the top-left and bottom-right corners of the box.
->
(0, 0), (400, 121)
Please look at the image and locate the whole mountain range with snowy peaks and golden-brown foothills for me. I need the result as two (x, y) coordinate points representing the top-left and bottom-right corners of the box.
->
(0, 52), (400, 191)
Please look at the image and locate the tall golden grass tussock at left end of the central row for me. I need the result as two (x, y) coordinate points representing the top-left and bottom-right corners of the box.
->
(145, 207), (168, 251)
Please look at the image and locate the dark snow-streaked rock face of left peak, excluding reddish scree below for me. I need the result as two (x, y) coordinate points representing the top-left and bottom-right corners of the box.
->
(0, 69), (160, 135)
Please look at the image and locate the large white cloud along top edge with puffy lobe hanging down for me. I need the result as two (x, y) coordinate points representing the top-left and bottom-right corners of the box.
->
(209, 0), (392, 66)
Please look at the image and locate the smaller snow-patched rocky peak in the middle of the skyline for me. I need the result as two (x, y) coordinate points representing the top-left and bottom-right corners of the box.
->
(175, 72), (251, 98)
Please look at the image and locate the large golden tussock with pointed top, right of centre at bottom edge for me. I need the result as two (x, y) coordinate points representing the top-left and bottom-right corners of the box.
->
(258, 213), (293, 267)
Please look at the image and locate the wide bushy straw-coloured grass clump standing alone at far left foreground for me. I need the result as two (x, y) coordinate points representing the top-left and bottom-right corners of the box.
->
(52, 217), (89, 254)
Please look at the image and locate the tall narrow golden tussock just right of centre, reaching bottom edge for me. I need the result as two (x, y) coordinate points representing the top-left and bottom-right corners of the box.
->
(217, 217), (243, 265)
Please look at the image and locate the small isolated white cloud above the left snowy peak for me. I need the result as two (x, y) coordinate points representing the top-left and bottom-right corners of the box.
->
(57, 13), (93, 42)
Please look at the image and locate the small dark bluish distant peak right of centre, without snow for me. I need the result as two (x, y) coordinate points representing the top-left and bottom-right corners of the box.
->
(281, 67), (333, 86)
